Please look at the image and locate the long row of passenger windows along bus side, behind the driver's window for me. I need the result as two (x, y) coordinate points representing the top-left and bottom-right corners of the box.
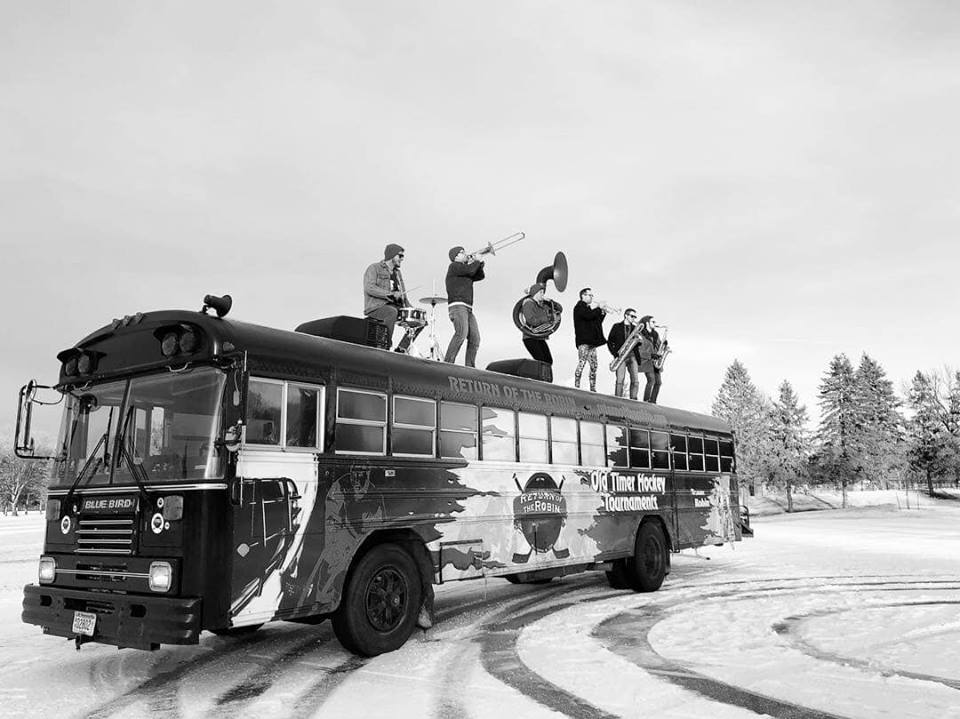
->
(335, 388), (733, 472)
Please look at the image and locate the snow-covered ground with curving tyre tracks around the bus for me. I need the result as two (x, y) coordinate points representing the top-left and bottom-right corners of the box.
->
(0, 503), (960, 719)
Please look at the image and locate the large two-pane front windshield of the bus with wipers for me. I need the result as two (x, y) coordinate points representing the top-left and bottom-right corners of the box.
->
(54, 367), (226, 485)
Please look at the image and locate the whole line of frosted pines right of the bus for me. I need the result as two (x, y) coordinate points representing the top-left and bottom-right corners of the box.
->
(712, 353), (960, 511)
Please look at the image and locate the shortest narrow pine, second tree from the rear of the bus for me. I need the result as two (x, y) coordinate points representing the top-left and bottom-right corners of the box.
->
(765, 380), (808, 512)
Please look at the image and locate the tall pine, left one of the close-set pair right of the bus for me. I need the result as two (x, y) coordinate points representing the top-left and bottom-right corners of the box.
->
(817, 354), (863, 507)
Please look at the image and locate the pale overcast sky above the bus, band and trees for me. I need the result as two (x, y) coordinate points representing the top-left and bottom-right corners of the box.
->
(0, 0), (960, 442)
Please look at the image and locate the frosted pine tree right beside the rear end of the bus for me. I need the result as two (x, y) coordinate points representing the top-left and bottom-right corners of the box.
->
(711, 360), (767, 493)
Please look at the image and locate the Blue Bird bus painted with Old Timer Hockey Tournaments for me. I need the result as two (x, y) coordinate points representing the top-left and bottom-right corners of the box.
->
(17, 296), (741, 656)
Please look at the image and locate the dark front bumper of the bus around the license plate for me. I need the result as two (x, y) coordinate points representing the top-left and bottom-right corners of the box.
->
(21, 584), (201, 649)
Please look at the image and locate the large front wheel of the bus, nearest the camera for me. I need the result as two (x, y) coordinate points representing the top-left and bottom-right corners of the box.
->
(331, 544), (423, 657)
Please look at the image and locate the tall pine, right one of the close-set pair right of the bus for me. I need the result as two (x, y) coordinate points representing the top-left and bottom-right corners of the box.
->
(854, 353), (905, 488)
